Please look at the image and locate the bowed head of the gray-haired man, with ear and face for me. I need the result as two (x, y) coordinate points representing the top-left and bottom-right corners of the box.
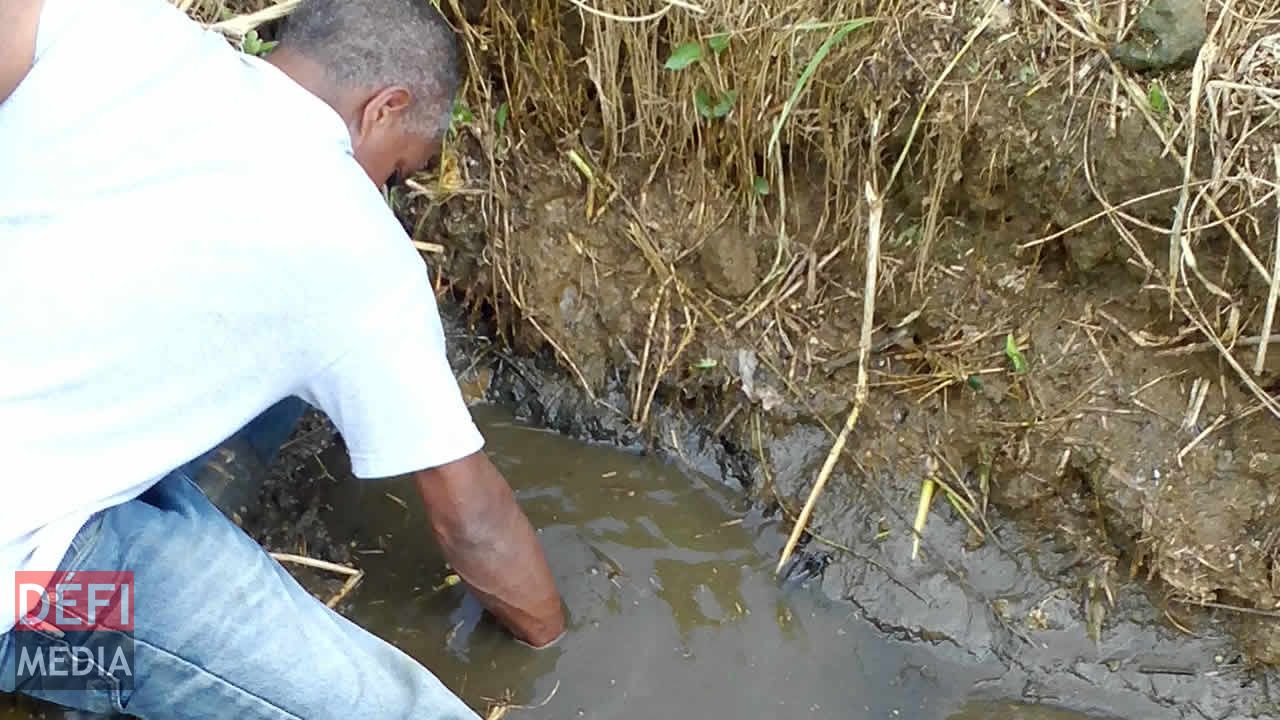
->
(270, 0), (461, 184)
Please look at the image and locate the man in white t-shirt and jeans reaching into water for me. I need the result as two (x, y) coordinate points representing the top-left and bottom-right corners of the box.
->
(0, 0), (564, 720)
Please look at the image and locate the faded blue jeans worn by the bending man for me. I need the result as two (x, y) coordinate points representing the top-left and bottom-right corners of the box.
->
(0, 398), (477, 720)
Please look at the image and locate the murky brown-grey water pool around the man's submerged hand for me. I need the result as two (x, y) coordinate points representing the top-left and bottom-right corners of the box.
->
(0, 409), (1105, 720)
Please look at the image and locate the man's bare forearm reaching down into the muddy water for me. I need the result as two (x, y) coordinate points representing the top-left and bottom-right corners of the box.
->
(414, 448), (564, 647)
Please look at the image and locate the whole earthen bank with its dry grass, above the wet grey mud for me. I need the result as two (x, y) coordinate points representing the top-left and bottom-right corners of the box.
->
(412, 0), (1280, 681)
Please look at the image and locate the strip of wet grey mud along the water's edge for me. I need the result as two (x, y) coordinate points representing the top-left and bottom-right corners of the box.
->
(424, 301), (1274, 719)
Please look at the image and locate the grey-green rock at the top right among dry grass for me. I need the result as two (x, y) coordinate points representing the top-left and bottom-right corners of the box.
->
(1111, 0), (1208, 72)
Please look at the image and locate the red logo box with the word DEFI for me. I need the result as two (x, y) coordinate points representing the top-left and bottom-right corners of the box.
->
(14, 570), (136, 634)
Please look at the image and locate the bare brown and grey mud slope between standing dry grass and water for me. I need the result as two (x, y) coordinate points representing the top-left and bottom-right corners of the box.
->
(413, 11), (1280, 716)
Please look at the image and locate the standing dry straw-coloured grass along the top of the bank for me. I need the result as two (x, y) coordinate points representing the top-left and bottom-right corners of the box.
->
(427, 0), (1280, 419)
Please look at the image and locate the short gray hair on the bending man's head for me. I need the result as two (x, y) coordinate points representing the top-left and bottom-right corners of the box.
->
(280, 0), (462, 136)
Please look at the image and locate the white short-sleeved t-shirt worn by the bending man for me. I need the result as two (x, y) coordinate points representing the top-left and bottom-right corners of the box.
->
(0, 0), (483, 633)
